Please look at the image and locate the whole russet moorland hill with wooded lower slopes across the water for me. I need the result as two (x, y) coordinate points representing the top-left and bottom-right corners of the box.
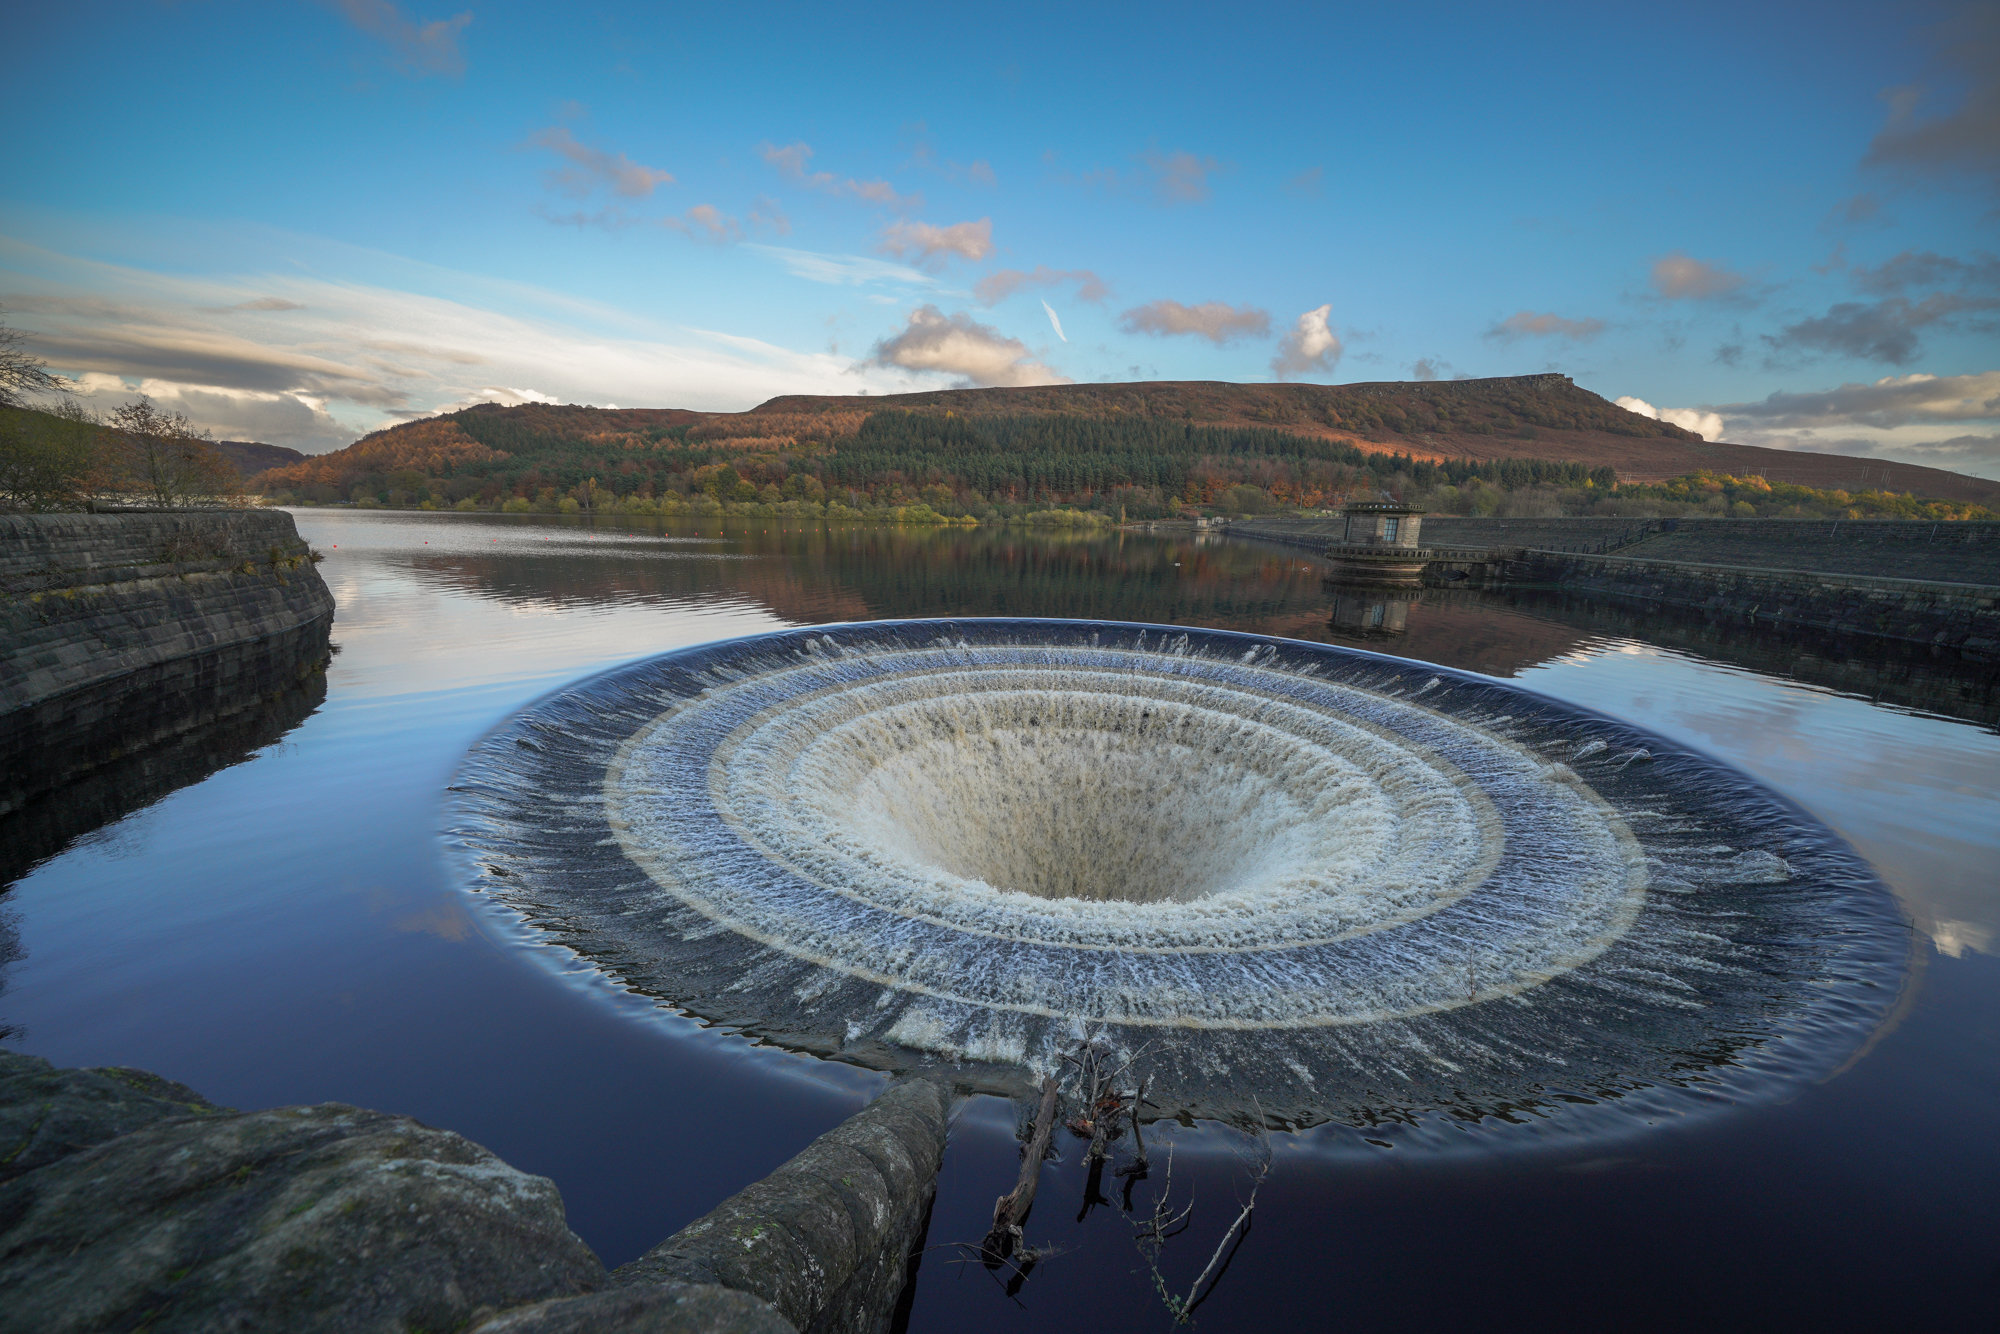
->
(256, 376), (2000, 518)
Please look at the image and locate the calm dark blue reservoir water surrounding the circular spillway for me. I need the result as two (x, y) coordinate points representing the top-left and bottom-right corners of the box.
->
(0, 510), (2000, 1334)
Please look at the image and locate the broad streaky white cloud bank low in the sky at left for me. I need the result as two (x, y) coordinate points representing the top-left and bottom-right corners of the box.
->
(0, 238), (922, 452)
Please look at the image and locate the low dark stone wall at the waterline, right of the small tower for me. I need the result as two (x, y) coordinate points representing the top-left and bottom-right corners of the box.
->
(1496, 552), (2000, 660)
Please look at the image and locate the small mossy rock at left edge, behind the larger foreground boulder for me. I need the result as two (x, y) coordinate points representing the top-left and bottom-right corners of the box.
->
(0, 1052), (228, 1182)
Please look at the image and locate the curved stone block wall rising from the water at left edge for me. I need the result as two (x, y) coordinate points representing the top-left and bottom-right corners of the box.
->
(0, 510), (334, 814)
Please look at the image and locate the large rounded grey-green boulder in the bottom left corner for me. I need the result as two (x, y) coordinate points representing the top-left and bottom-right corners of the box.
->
(0, 1104), (606, 1334)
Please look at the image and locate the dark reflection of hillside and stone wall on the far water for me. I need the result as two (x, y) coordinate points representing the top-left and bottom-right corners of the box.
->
(398, 524), (2000, 724)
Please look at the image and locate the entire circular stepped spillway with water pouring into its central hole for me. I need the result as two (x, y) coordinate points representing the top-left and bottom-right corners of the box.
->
(448, 620), (1906, 1130)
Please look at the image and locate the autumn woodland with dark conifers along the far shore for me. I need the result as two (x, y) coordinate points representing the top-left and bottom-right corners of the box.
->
(264, 408), (1616, 518)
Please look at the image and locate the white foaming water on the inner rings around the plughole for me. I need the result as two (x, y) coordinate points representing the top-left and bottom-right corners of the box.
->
(604, 648), (1646, 1028)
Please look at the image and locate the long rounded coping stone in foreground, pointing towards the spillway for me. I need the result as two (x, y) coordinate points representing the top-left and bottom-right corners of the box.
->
(614, 1080), (950, 1334)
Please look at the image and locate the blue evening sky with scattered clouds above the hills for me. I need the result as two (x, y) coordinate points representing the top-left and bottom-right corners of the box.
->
(0, 0), (2000, 476)
